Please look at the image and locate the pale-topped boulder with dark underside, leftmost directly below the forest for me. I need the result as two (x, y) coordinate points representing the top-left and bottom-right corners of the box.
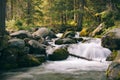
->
(10, 30), (32, 39)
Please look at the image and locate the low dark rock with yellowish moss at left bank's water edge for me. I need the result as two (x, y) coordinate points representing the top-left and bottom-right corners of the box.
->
(18, 54), (41, 67)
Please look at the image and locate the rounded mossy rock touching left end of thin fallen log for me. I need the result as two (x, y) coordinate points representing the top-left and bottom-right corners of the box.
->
(48, 48), (69, 61)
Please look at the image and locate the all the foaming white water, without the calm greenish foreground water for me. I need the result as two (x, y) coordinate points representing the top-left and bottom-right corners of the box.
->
(45, 38), (111, 72)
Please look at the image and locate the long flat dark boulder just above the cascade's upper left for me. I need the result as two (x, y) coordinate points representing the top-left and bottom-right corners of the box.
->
(55, 38), (77, 45)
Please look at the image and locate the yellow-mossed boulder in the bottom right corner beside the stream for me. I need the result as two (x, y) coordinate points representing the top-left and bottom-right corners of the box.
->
(106, 51), (120, 80)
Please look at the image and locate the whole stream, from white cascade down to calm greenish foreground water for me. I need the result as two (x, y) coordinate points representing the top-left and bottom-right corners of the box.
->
(0, 33), (111, 80)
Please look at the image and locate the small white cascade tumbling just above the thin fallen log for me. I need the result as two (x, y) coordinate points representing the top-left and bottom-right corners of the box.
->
(68, 39), (111, 61)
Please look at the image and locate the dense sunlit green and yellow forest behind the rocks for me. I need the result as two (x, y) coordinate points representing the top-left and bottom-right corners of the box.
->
(6, 0), (120, 35)
